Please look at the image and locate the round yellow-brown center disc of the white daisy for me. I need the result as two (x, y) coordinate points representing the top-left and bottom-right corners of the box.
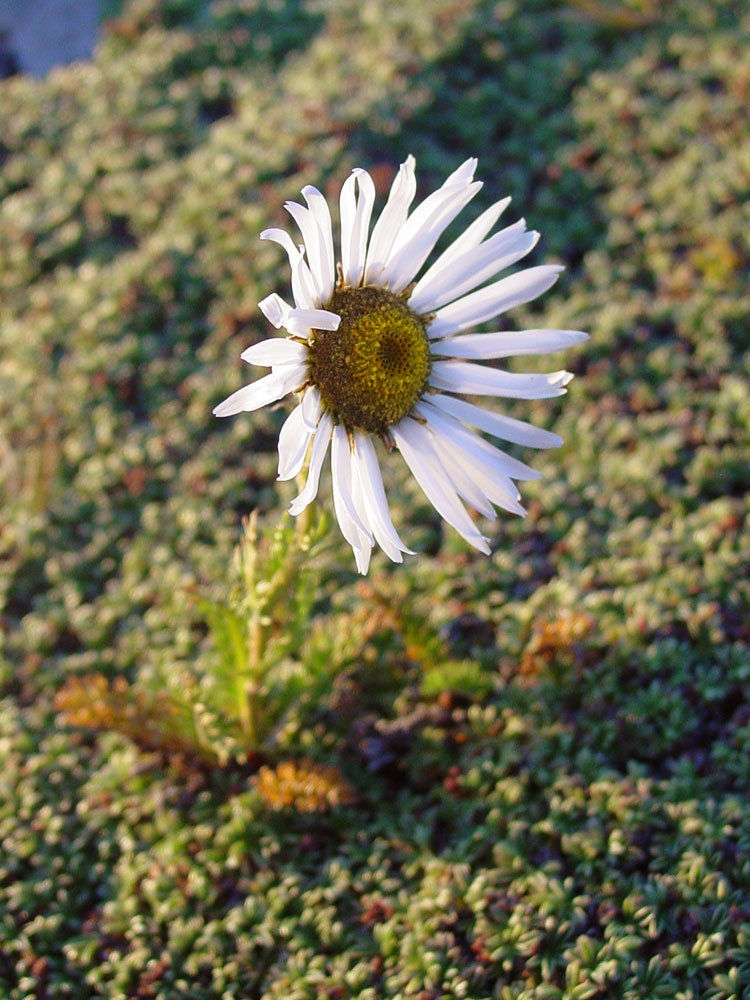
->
(310, 285), (430, 434)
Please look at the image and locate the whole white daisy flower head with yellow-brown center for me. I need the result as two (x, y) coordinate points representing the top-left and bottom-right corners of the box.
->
(214, 156), (587, 573)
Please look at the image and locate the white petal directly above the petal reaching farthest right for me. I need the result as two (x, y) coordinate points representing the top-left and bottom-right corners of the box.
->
(427, 264), (564, 338)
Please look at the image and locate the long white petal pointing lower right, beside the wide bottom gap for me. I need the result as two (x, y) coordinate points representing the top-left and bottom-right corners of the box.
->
(390, 417), (490, 555)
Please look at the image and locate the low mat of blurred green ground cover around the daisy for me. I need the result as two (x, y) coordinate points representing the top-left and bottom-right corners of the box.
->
(0, 0), (750, 1000)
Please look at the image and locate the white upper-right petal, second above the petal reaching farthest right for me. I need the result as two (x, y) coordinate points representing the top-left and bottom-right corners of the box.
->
(409, 225), (539, 313)
